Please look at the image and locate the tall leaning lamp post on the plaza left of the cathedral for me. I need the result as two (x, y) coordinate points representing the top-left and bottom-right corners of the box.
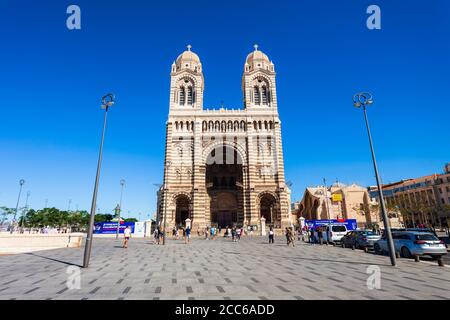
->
(83, 93), (114, 268)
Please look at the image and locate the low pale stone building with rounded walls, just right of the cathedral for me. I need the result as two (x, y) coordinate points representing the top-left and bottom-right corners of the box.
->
(294, 183), (381, 228)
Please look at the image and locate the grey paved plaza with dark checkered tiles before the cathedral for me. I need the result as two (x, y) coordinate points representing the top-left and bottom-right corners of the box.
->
(0, 237), (450, 300)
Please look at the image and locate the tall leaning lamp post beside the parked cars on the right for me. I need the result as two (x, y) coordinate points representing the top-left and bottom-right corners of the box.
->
(353, 92), (397, 267)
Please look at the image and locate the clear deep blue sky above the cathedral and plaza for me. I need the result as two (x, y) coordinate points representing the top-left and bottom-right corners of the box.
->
(0, 0), (450, 217)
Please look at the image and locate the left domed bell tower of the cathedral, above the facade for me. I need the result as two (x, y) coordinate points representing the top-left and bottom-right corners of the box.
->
(170, 45), (204, 113)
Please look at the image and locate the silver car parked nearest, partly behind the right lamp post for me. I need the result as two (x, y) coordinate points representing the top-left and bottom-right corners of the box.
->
(374, 231), (447, 258)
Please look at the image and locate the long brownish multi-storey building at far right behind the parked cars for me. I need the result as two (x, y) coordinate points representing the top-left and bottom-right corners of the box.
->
(370, 164), (450, 227)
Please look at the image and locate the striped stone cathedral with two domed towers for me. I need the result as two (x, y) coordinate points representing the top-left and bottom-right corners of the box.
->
(157, 45), (295, 232)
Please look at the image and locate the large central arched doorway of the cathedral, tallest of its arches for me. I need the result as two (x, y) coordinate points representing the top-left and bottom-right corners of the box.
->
(205, 144), (244, 228)
